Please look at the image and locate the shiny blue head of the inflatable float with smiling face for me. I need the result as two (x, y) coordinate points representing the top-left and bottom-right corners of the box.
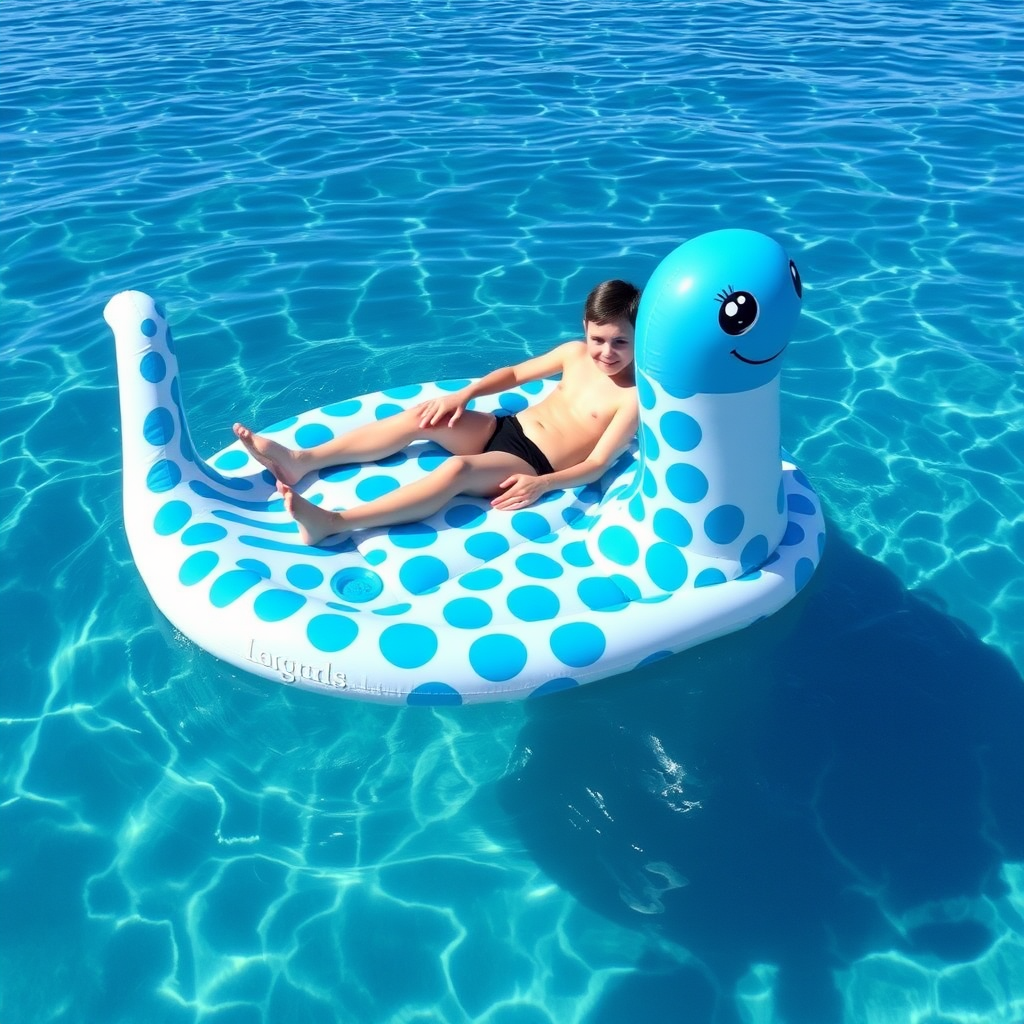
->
(636, 228), (802, 398)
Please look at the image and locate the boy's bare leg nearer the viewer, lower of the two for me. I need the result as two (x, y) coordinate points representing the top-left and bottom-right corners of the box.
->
(279, 452), (537, 544)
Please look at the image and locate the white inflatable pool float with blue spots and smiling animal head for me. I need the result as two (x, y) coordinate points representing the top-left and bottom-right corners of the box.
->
(103, 229), (824, 705)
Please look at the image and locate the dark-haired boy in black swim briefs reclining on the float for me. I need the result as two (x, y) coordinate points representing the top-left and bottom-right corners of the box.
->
(233, 281), (640, 544)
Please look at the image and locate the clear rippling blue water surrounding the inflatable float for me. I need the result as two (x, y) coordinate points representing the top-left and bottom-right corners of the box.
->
(0, 0), (1024, 1024)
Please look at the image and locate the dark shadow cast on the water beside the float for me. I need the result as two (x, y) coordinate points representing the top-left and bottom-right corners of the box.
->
(500, 527), (1024, 1024)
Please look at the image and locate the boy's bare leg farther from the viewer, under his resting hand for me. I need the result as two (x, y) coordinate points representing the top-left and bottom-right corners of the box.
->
(231, 410), (495, 485)
